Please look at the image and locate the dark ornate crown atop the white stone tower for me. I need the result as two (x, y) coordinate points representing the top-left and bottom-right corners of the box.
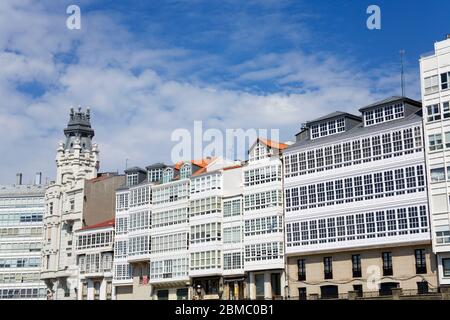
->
(64, 107), (94, 151)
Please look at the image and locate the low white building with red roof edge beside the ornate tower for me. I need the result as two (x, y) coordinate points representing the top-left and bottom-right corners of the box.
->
(75, 219), (115, 300)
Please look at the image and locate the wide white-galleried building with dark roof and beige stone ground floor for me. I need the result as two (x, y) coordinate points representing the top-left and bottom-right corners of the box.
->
(283, 97), (437, 299)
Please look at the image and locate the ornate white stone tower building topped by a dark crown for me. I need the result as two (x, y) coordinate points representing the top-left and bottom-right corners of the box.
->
(41, 108), (99, 300)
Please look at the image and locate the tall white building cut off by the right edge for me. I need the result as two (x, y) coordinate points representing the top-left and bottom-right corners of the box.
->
(420, 36), (450, 287)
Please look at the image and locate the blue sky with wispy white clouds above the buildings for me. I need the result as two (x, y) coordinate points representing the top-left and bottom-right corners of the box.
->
(0, 0), (450, 183)
